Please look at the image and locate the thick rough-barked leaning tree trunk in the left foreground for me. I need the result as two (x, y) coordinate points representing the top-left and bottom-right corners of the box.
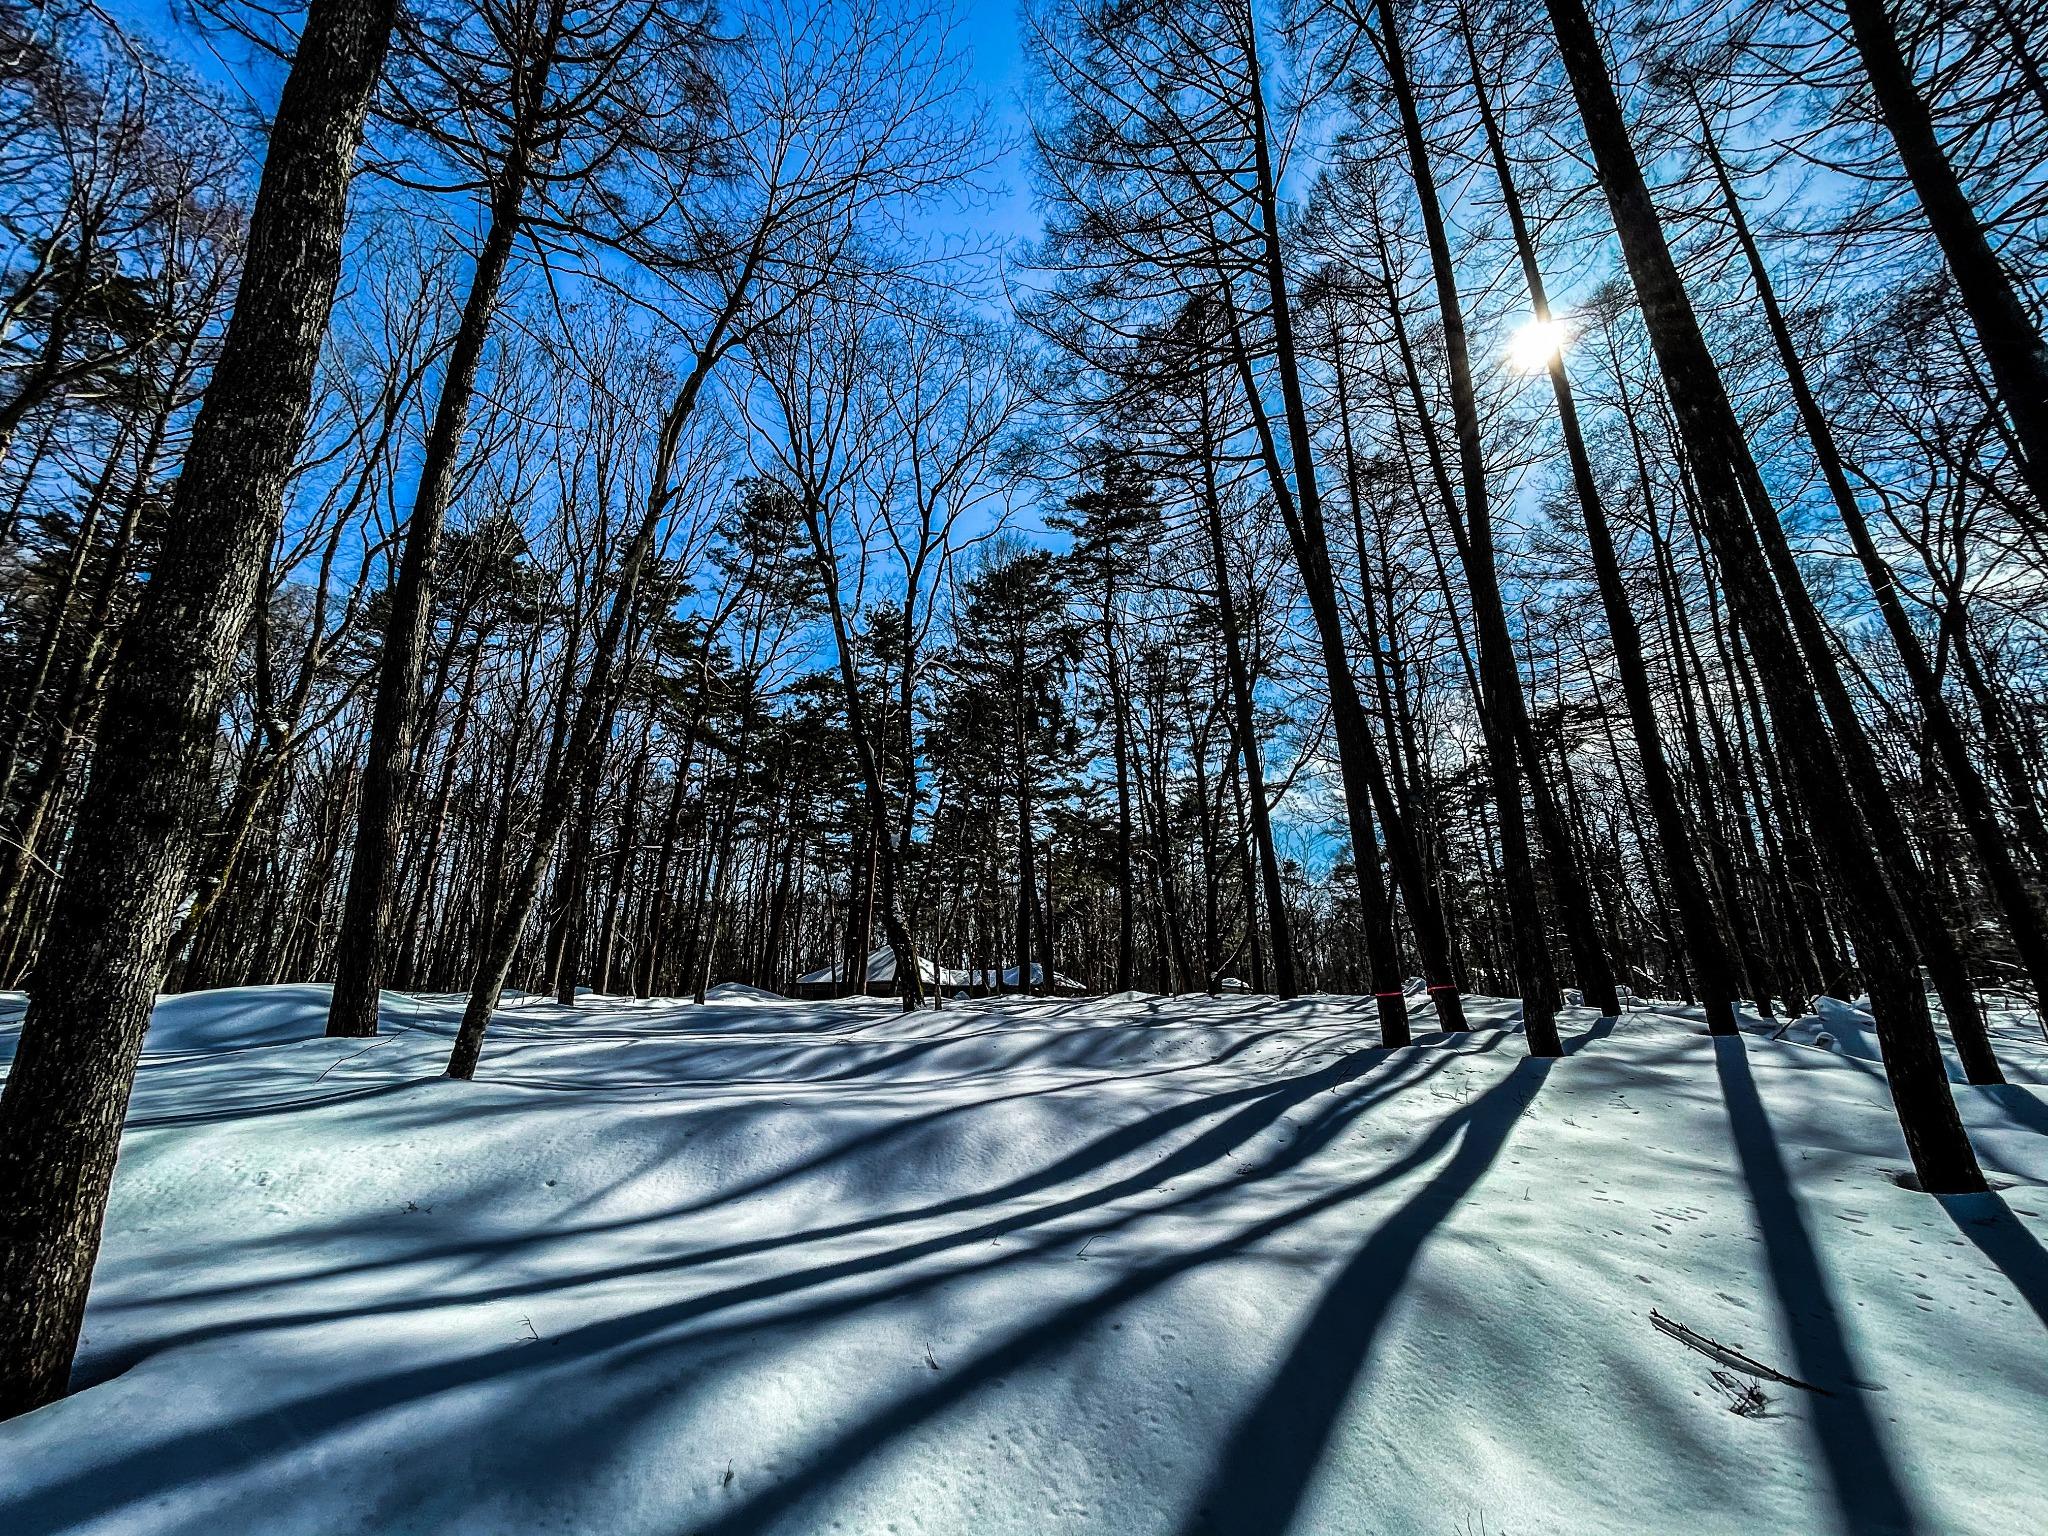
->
(0, 0), (393, 1417)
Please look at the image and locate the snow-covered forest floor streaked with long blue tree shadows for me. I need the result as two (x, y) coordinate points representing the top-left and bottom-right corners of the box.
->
(0, 987), (2048, 1536)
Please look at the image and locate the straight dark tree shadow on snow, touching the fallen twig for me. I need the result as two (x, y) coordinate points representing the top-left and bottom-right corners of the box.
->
(1714, 1034), (1925, 1536)
